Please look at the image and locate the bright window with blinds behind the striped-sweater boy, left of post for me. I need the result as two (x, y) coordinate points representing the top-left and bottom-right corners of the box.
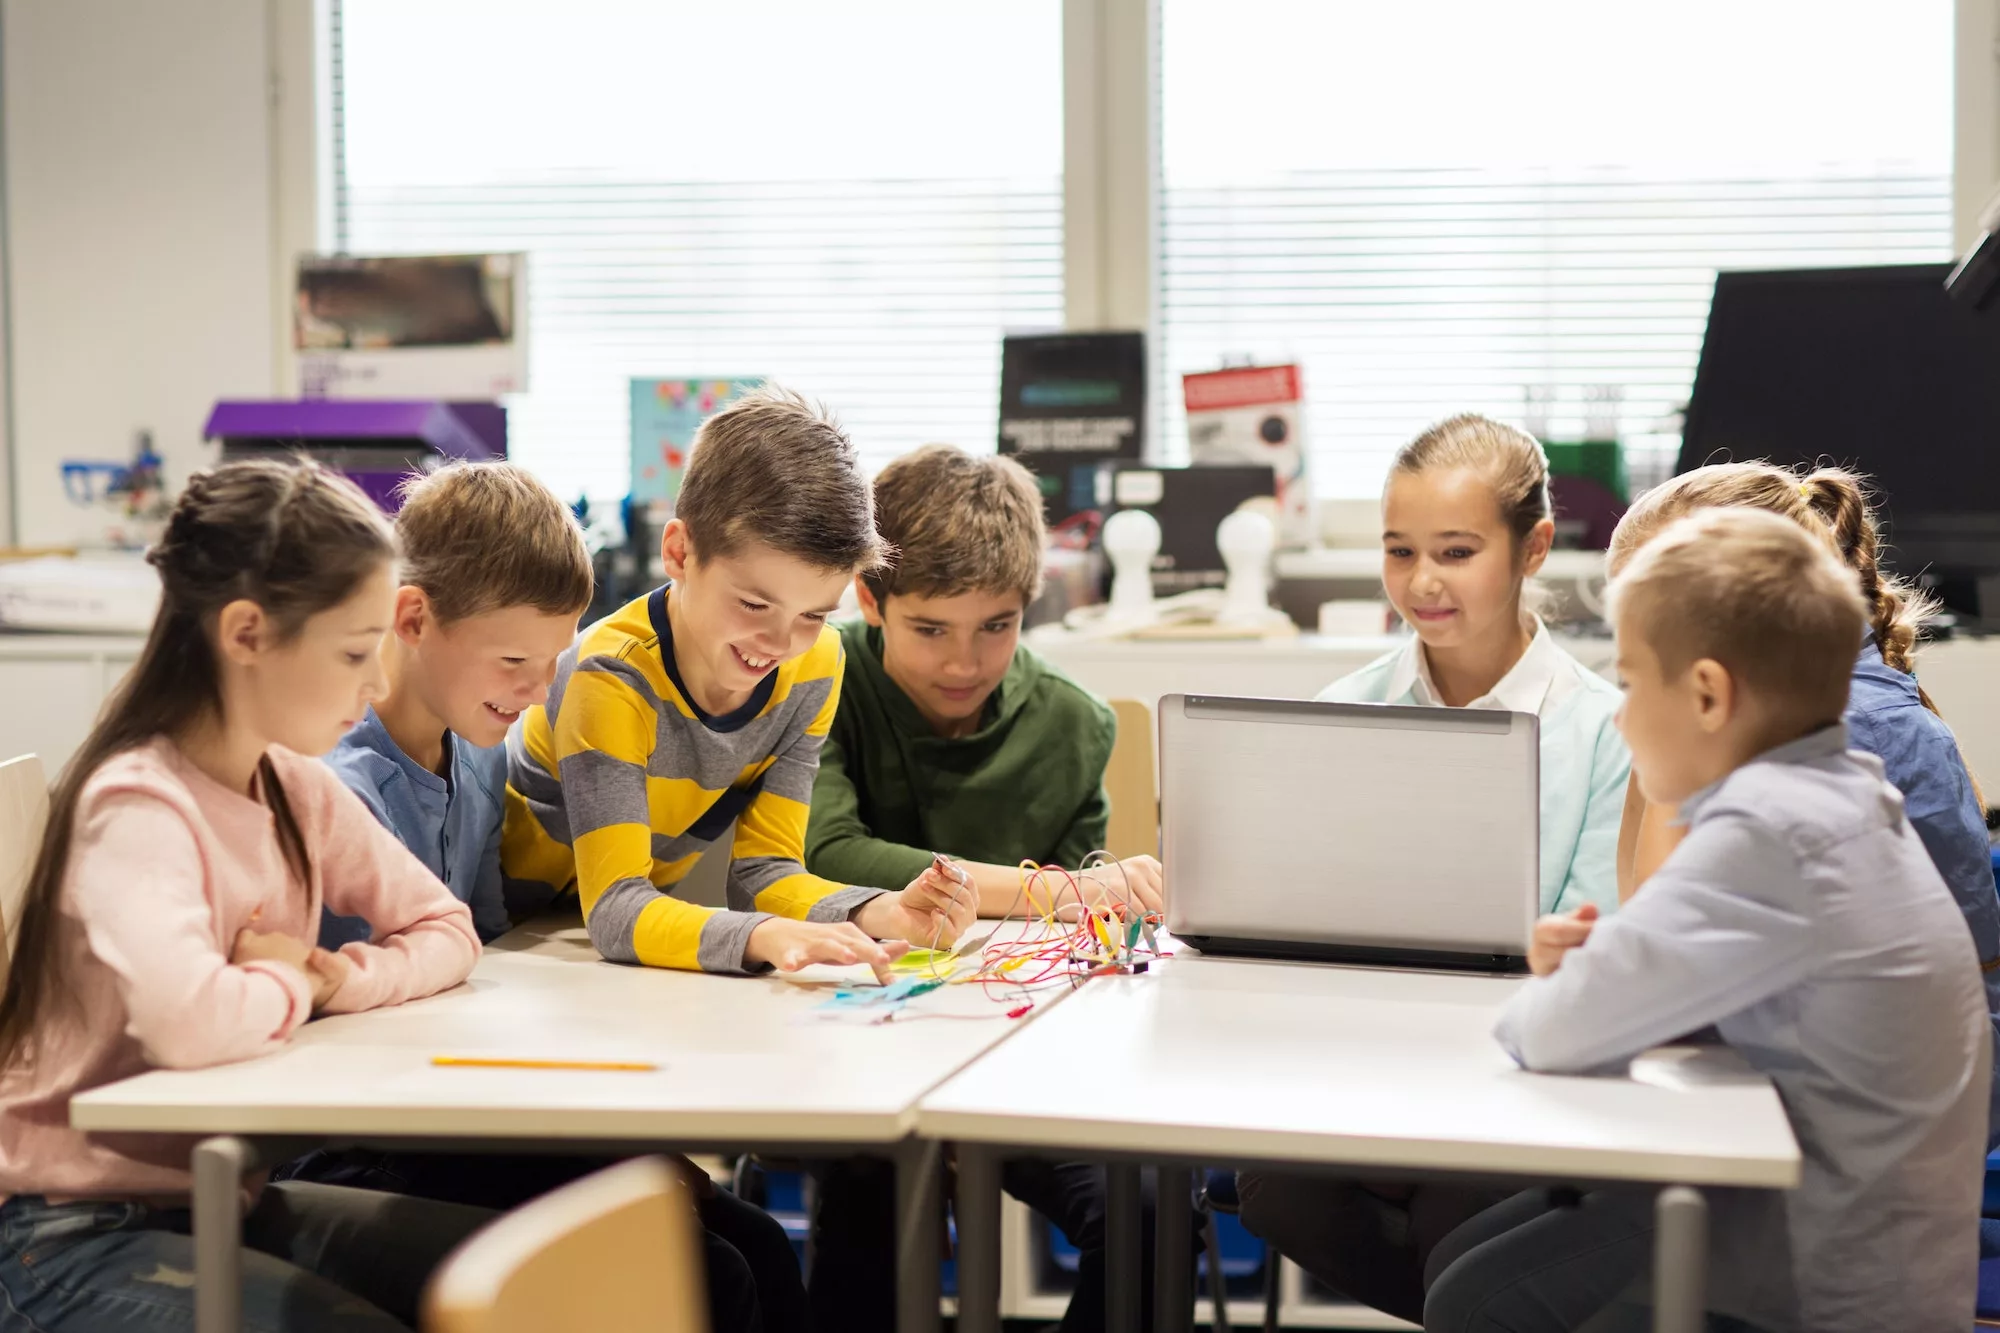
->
(332, 0), (1062, 500)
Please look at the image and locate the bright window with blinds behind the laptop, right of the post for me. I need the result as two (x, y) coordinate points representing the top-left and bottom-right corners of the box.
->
(1160, 0), (1952, 496)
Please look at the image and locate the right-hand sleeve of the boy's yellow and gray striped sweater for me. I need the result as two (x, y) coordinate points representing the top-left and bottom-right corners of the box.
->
(728, 630), (882, 921)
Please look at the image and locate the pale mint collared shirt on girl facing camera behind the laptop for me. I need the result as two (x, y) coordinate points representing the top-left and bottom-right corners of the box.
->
(1318, 620), (1632, 913)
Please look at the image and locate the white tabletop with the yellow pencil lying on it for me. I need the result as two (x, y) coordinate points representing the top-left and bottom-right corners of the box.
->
(70, 917), (1060, 1143)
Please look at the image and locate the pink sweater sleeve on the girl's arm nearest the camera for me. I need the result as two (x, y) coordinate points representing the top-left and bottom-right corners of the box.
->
(64, 791), (312, 1069)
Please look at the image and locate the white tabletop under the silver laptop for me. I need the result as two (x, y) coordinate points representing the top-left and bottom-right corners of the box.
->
(918, 957), (1798, 1187)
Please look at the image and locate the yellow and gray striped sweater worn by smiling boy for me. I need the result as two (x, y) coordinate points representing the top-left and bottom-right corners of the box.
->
(500, 588), (878, 973)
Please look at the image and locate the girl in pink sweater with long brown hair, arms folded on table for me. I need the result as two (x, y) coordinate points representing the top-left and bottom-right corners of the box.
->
(0, 462), (490, 1333)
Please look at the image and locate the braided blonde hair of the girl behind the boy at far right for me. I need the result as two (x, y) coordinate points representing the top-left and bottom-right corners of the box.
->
(1610, 462), (1938, 676)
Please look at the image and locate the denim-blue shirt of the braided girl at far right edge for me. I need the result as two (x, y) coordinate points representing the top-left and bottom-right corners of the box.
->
(1846, 634), (2000, 1151)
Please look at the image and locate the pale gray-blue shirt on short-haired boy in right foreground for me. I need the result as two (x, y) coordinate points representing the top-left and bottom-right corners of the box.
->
(1494, 723), (1992, 1333)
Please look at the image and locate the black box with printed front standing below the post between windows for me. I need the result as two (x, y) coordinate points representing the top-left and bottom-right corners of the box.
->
(1000, 332), (1146, 526)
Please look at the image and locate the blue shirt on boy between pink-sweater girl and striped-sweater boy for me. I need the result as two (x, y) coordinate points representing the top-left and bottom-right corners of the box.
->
(320, 709), (510, 949)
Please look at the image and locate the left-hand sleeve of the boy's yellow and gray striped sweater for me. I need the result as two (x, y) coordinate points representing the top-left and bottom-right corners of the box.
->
(554, 656), (732, 971)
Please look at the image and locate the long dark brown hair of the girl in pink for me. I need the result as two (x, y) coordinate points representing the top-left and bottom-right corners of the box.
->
(0, 460), (396, 1065)
